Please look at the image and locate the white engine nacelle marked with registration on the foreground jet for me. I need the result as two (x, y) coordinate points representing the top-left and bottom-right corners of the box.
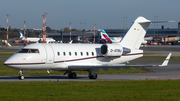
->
(100, 44), (123, 56)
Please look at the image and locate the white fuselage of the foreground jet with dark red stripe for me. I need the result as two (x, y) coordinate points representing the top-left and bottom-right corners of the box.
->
(4, 43), (143, 70)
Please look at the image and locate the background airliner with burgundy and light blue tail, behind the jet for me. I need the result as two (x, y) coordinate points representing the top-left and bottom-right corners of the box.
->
(100, 29), (147, 44)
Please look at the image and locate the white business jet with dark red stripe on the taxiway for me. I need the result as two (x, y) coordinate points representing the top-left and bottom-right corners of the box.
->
(4, 17), (171, 80)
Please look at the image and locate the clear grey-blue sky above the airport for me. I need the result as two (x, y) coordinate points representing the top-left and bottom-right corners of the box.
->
(0, 0), (180, 30)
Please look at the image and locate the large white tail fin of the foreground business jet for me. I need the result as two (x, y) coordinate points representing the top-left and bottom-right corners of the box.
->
(120, 17), (151, 49)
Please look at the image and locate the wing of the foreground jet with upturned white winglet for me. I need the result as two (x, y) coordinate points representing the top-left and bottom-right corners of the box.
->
(68, 53), (172, 72)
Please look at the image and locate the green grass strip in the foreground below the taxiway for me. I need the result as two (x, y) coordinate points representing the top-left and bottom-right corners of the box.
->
(0, 80), (180, 101)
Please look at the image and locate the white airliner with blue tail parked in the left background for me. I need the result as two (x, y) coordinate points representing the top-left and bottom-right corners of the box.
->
(19, 30), (55, 43)
